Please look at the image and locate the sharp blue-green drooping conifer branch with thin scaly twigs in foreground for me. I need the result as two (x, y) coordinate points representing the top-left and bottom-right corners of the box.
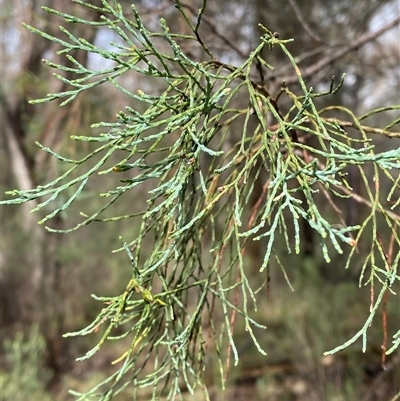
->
(2, 0), (400, 400)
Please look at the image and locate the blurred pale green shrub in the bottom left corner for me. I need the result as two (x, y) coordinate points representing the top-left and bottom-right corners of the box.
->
(0, 326), (51, 401)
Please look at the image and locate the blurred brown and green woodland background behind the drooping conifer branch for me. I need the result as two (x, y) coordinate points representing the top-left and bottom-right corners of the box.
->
(0, 0), (400, 401)
